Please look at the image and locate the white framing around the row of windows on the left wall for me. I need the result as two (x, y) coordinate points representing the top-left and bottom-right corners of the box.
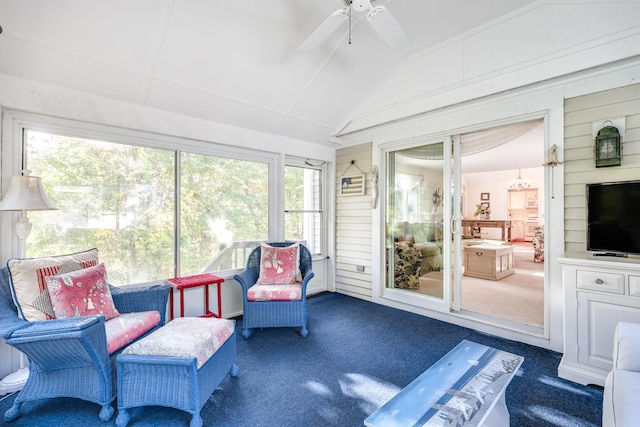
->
(0, 110), (320, 277)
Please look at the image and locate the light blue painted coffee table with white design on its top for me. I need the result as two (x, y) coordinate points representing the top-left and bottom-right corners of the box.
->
(364, 340), (524, 427)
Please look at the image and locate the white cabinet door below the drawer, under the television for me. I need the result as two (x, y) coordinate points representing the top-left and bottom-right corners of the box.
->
(577, 292), (640, 369)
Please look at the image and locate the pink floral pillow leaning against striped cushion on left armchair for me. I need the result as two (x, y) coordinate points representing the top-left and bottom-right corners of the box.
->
(47, 264), (120, 320)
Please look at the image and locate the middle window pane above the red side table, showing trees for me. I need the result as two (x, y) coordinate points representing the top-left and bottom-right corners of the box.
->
(180, 153), (269, 274)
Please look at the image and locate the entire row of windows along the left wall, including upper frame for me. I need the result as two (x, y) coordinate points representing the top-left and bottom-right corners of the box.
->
(15, 115), (325, 285)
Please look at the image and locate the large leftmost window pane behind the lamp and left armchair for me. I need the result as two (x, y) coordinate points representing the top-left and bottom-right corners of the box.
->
(25, 130), (175, 284)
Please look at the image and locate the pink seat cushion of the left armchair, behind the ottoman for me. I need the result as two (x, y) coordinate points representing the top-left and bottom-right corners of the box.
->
(104, 311), (160, 354)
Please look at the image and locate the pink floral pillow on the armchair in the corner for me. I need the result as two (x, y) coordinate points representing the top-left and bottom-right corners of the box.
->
(256, 243), (300, 285)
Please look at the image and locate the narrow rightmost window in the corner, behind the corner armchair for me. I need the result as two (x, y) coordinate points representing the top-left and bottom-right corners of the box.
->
(284, 166), (324, 255)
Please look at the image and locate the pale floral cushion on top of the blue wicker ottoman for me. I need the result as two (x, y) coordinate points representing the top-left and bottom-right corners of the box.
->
(122, 317), (235, 369)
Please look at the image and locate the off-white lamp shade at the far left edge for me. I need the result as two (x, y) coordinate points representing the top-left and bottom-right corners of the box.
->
(0, 176), (58, 211)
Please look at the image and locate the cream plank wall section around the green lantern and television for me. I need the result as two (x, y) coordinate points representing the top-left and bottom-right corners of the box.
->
(564, 84), (640, 252)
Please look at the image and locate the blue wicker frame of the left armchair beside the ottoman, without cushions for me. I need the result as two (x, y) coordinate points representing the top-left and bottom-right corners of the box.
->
(0, 268), (171, 421)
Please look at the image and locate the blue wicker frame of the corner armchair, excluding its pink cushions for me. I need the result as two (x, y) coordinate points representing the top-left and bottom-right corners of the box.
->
(234, 242), (313, 338)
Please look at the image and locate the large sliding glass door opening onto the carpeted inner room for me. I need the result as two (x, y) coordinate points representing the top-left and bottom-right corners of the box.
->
(384, 120), (545, 329)
